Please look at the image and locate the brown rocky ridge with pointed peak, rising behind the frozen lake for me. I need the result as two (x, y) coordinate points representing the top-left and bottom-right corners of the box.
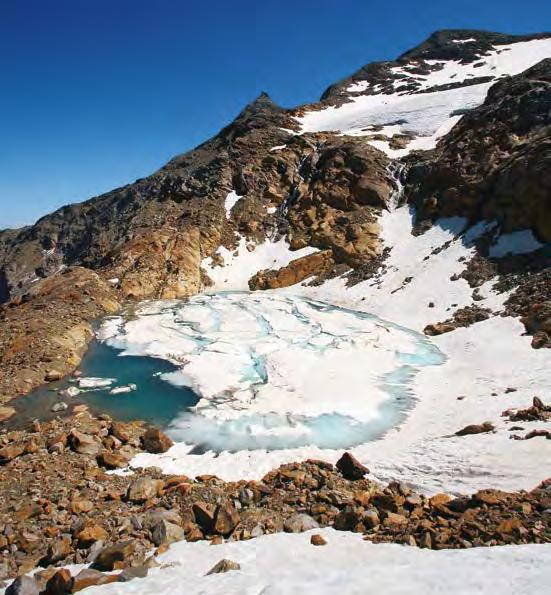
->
(0, 94), (393, 301)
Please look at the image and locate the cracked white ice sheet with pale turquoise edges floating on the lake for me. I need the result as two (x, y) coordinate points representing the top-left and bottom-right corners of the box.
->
(99, 292), (443, 452)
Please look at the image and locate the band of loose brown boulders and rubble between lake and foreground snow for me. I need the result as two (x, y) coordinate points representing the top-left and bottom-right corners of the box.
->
(0, 410), (551, 594)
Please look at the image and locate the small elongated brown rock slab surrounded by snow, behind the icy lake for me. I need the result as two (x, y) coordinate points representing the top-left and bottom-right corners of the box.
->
(249, 250), (334, 291)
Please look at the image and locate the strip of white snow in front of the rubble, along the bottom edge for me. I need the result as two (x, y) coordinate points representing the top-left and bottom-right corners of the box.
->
(59, 529), (551, 595)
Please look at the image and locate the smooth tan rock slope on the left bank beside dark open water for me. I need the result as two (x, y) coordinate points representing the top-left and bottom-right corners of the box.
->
(0, 267), (120, 417)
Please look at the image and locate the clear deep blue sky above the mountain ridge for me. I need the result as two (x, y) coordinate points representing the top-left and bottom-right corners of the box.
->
(0, 0), (551, 228)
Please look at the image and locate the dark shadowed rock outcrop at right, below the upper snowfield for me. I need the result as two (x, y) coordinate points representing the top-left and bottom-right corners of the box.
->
(406, 59), (551, 241)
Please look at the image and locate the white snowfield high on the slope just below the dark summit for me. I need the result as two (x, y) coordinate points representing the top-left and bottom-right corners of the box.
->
(297, 39), (551, 158)
